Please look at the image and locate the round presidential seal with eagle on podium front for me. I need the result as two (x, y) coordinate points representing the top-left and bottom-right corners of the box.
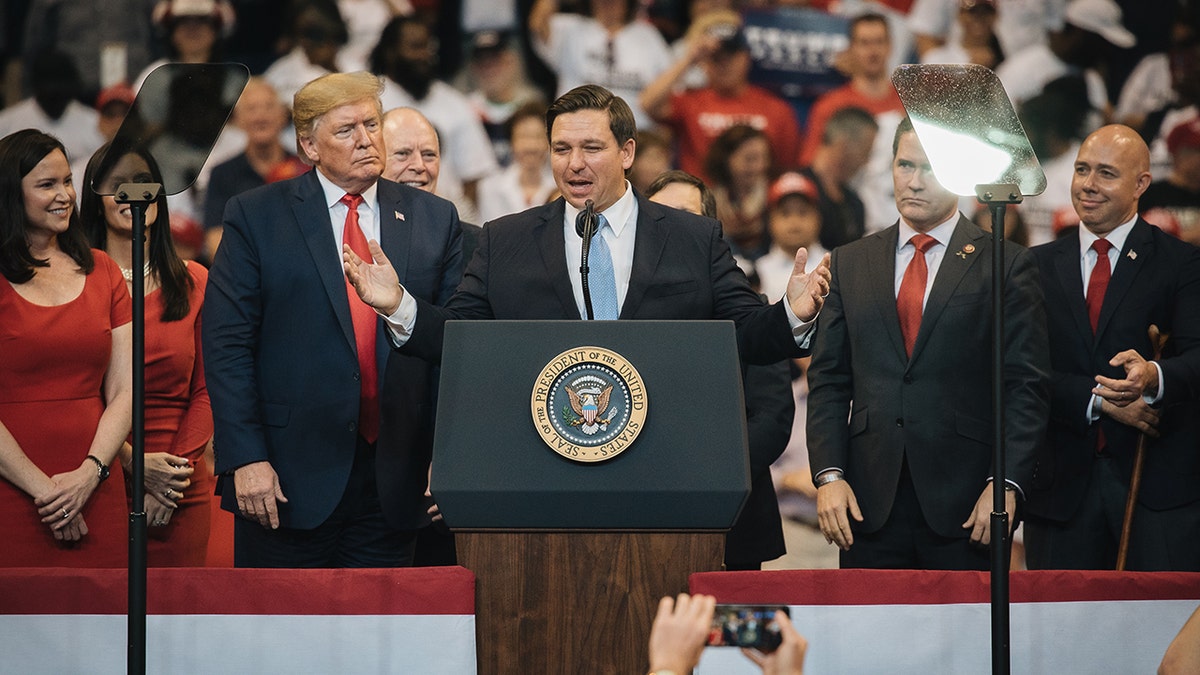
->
(530, 347), (646, 462)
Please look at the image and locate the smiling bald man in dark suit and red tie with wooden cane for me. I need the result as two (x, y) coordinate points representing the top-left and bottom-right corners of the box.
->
(1025, 125), (1200, 572)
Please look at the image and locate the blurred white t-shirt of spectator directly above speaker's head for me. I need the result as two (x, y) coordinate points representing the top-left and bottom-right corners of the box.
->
(533, 13), (672, 129)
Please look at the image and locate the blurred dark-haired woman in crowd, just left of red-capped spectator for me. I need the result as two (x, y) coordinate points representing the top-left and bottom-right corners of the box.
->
(704, 124), (774, 269)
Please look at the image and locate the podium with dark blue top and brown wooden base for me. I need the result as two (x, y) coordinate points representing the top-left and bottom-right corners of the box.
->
(431, 321), (750, 675)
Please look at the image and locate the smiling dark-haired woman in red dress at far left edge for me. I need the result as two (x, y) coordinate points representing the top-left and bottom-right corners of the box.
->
(0, 129), (133, 567)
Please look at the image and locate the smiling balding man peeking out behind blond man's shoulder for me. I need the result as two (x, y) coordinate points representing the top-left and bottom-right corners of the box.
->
(383, 108), (480, 263)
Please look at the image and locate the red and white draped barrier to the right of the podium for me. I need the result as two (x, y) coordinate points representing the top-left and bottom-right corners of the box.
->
(690, 569), (1200, 675)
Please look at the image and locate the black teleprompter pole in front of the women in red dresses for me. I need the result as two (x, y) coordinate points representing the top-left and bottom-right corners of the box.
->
(115, 183), (162, 675)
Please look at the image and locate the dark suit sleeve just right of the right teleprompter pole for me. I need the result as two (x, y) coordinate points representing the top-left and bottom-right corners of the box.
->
(1004, 246), (1051, 490)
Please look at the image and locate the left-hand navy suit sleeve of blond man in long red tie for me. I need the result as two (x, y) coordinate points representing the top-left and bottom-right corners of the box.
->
(202, 193), (268, 474)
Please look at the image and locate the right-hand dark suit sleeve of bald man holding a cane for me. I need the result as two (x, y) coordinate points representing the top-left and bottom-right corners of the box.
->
(1142, 243), (1200, 406)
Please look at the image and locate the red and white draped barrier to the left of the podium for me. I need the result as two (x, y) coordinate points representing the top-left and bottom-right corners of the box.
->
(0, 567), (475, 675)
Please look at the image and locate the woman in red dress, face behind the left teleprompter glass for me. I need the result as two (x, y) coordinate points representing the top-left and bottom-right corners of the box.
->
(79, 145), (214, 567)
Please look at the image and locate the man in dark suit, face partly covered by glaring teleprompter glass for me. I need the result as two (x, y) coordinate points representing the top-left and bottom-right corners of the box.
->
(808, 119), (1049, 569)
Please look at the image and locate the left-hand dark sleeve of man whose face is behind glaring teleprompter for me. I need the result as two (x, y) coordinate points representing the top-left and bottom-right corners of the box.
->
(805, 242), (853, 476)
